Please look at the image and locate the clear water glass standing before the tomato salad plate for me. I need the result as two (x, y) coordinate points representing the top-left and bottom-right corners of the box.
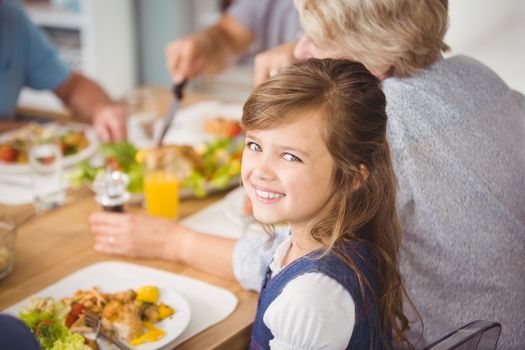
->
(29, 139), (66, 211)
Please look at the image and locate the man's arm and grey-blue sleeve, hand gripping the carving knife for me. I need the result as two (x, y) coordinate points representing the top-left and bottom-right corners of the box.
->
(166, 0), (302, 83)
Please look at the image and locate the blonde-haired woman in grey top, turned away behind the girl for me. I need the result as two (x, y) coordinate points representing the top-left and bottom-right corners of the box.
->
(251, 0), (525, 349)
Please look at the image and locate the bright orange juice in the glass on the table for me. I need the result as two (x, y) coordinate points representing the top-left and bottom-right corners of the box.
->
(144, 170), (179, 219)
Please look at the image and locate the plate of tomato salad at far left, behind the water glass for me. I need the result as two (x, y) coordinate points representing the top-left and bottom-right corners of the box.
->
(0, 123), (98, 174)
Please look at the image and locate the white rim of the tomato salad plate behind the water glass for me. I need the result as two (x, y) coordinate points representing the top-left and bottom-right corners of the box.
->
(0, 123), (98, 174)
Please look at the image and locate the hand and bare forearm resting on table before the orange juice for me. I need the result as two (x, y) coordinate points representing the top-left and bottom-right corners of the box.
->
(89, 212), (237, 280)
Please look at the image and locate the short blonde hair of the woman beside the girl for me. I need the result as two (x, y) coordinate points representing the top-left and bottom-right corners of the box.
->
(294, 0), (448, 77)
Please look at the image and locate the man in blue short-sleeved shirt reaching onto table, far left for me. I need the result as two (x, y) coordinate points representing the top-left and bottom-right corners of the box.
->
(0, 0), (126, 141)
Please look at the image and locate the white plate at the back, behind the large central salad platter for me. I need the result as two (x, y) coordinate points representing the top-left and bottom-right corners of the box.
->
(162, 101), (242, 147)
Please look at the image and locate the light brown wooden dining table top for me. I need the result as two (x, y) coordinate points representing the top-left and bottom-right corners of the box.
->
(0, 91), (258, 349)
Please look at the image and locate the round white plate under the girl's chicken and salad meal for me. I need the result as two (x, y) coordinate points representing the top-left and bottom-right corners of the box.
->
(4, 262), (191, 350)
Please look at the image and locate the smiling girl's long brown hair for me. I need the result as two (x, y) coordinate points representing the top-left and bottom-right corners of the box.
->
(242, 59), (414, 344)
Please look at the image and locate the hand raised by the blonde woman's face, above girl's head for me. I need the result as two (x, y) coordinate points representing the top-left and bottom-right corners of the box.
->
(253, 42), (296, 86)
